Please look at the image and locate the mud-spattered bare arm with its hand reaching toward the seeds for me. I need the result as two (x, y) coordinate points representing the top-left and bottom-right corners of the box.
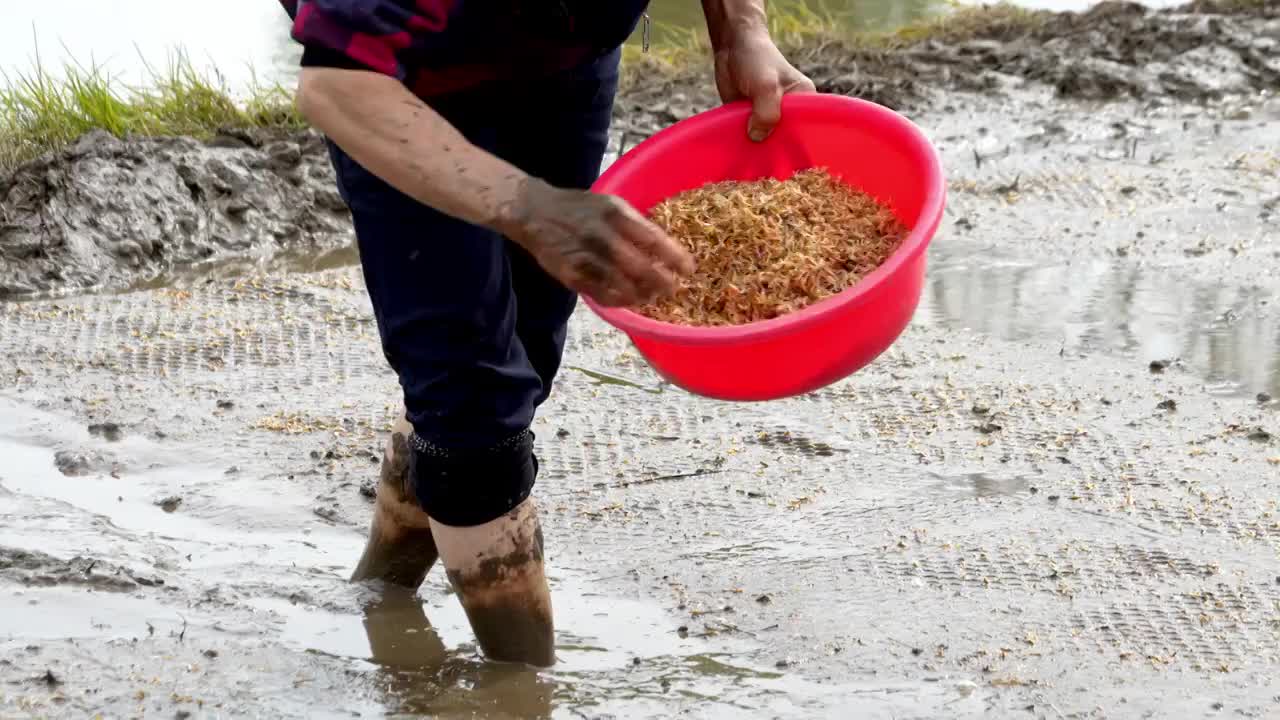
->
(297, 67), (692, 305)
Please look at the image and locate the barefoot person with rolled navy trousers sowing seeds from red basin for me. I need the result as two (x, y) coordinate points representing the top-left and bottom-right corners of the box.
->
(283, 0), (813, 666)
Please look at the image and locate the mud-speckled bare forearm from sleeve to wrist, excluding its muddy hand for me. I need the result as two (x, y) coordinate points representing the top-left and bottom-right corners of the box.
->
(298, 68), (529, 227)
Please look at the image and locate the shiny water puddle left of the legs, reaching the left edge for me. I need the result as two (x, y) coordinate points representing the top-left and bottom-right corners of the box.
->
(0, 400), (362, 577)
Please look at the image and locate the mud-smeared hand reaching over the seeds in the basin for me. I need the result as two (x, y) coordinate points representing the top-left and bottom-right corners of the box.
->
(495, 178), (694, 306)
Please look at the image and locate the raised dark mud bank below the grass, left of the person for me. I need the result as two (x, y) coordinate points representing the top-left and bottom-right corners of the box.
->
(0, 126), (351, 299)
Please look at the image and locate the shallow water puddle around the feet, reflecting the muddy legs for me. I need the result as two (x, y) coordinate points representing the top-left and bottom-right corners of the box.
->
(241, 571), (979, 717)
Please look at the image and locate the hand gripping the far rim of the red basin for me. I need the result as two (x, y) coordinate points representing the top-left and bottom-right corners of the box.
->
(716, 28), (814, 142)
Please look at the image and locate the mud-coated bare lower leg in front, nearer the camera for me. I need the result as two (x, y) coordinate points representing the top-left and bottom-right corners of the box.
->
(431, 500), (556, 667)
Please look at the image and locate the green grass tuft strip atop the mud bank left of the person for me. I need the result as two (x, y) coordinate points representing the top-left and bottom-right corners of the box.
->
(0, 49), (303, 172)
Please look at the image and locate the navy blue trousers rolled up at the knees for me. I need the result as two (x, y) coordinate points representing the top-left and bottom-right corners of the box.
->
(322, 51), (620, 521)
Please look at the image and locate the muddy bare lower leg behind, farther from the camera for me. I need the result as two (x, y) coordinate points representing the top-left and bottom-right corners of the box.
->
(351, 416), (439, 589)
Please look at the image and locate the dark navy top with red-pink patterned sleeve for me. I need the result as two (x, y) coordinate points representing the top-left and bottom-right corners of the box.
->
(280, 0), (649, 97)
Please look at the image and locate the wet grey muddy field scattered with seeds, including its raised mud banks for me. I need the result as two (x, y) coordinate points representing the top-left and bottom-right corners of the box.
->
(0, 4), (1280, 719)
